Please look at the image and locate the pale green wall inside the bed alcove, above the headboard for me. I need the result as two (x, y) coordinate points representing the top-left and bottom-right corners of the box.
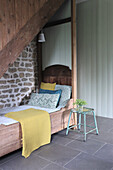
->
(42, 0), (71, 70)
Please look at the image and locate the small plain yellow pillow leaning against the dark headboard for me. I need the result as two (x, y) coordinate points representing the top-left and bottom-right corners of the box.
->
(40, 82), (56, 90)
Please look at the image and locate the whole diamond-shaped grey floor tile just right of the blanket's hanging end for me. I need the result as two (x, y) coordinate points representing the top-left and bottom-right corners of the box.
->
(38, 144), (80, 166)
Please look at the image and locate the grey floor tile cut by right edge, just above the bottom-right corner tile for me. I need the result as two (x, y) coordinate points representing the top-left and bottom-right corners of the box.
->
(95, 144), (113, 162)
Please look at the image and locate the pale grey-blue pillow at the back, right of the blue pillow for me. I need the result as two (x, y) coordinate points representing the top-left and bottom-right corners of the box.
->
(55, 84), (72, 105)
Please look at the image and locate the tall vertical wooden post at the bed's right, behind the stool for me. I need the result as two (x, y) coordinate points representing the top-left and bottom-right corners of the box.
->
(71, 0), (77, 124)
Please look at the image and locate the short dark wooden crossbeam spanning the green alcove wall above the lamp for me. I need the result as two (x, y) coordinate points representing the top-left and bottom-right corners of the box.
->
(44, 17), (71, 28)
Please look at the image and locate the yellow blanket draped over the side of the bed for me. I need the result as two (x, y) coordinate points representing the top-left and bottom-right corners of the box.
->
(5, 108), (51, 158)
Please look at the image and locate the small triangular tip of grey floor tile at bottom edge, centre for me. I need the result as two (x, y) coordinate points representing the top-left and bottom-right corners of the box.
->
(43, 163), (67, 170)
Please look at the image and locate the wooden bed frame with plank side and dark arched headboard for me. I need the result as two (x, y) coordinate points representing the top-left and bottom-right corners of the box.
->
(0, 65), (75, 157)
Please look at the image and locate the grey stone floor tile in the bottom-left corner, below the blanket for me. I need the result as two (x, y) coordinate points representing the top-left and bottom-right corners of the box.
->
(1, 155), (50, 170)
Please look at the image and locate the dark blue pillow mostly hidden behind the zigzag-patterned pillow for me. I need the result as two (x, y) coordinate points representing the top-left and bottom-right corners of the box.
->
(39, 89), (62, 105)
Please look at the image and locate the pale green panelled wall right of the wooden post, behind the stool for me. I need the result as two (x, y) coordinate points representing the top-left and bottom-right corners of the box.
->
(77, 0), (113, 118)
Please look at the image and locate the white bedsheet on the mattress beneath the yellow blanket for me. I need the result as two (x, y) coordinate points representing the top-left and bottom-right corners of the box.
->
(0, 105), (61, 125)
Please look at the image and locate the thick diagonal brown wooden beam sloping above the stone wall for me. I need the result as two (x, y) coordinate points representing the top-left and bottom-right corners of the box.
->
(0, 0), (64, 77)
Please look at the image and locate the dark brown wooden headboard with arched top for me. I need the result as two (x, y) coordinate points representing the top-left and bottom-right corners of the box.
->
(42, 65), (72, 86)
